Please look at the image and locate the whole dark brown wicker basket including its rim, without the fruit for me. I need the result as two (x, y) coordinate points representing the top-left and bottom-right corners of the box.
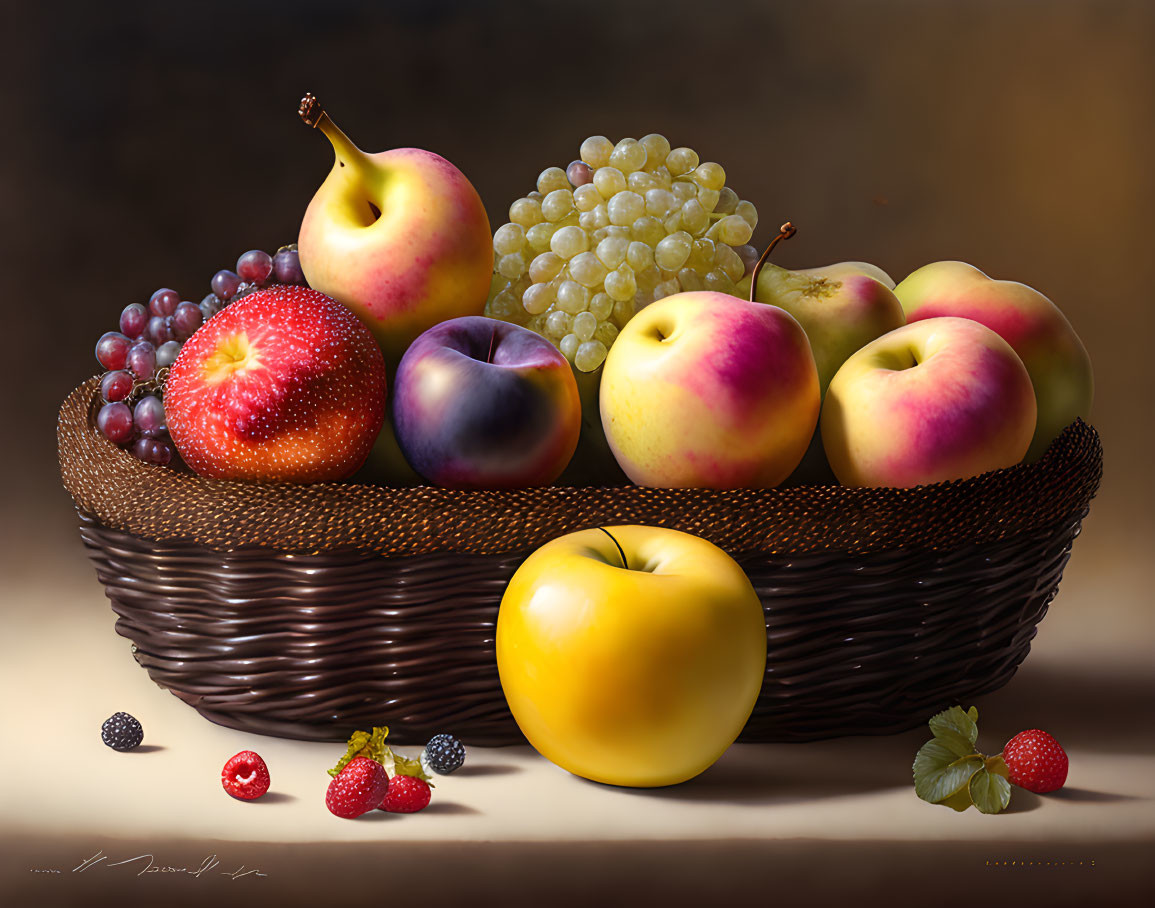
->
(58, 379), (1102, 745)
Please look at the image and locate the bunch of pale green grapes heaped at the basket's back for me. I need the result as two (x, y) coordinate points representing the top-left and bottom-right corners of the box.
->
(485, 134), (758, 372)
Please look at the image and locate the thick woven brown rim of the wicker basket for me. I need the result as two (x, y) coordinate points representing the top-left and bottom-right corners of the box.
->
(57, 375), (1102, 555)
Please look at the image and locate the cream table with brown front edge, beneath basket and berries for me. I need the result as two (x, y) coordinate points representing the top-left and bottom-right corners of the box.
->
(0, 508), (1155, 903)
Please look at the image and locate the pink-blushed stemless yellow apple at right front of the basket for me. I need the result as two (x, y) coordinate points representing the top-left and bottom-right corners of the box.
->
(821, 318), (1036, 488)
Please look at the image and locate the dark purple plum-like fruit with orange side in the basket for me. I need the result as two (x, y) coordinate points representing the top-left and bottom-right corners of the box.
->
(393, 315), (581, 489)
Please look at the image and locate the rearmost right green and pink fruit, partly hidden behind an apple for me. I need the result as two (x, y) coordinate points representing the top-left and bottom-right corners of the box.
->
(894, 262), (1095, 461)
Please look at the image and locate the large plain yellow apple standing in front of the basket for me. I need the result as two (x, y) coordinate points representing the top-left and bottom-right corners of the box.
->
(497, 527), (766, 788)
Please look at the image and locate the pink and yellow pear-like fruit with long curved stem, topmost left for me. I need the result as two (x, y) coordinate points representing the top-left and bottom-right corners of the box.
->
(297, 96), (493, 360)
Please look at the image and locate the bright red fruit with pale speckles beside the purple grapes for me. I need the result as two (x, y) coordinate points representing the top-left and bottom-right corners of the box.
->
(164, 286), (386, 483)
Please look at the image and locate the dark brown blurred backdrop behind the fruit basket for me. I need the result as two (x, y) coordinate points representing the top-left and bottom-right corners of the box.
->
(0, 0), (1155, 901)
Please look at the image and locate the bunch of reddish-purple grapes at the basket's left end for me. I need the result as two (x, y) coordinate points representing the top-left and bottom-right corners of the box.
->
(96, 244), (305, 464)
